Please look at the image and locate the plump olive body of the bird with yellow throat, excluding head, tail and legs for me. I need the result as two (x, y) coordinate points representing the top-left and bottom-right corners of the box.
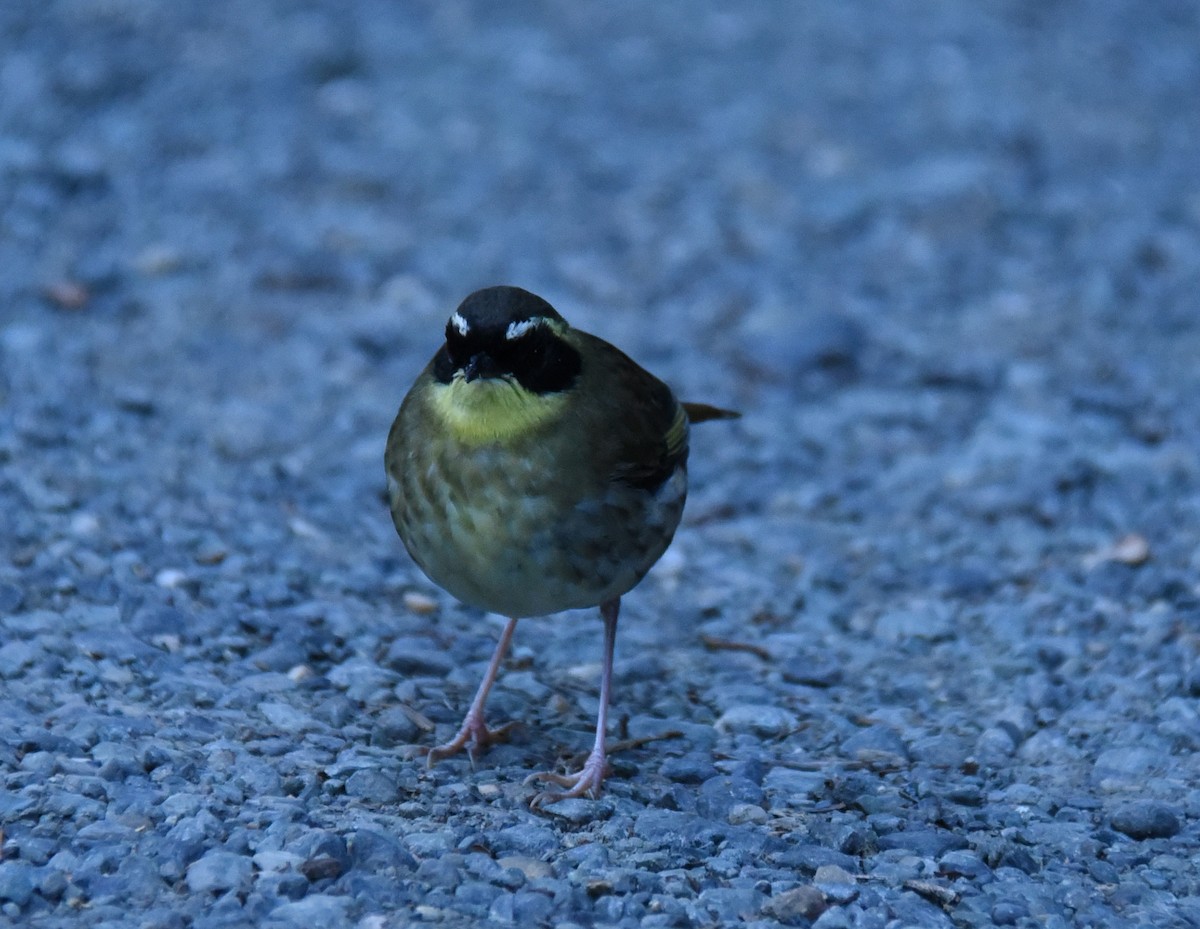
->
(385, 330), (686, 616)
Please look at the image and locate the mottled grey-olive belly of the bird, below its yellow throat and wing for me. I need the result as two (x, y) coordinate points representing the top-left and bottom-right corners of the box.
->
(389, 446), (686, 617)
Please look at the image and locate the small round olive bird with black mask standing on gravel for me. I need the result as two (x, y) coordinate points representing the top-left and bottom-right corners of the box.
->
(384, 287), (738, 807)
